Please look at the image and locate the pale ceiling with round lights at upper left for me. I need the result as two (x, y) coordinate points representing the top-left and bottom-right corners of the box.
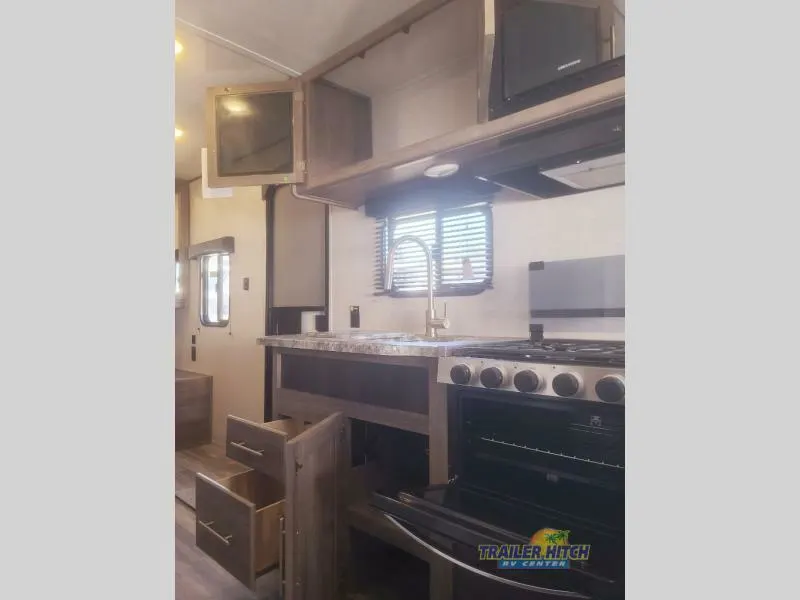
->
(175, 0), (417, 180)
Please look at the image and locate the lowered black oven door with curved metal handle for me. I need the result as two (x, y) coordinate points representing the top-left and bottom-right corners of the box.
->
(371, 485), (624, 600)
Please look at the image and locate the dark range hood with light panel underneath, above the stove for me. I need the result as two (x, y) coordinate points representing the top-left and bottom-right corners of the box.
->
(470, 106), (625, 198)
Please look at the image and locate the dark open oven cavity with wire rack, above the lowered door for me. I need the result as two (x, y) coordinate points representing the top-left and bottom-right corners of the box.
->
(458, 395), (625, 506)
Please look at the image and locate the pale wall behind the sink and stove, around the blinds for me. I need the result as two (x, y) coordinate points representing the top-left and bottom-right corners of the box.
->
(331, 187), (625, 339)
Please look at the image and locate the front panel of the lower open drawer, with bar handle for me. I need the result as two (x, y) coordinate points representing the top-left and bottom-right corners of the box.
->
(195, 473), (256, 590)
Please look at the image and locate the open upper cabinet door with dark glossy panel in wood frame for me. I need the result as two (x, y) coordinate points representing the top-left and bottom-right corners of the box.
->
(206, 79), (305, 187)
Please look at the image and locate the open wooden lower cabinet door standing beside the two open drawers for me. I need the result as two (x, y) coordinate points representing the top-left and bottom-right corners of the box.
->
(283, 413), (346, 600)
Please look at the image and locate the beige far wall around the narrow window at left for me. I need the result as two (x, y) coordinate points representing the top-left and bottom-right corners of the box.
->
(175, 180), (266, 442)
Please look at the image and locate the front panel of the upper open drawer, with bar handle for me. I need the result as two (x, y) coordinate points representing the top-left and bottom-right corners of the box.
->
(225, 416), (288, 481)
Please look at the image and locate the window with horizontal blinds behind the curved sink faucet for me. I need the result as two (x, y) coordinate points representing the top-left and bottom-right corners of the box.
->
(375, 202), (493, 296)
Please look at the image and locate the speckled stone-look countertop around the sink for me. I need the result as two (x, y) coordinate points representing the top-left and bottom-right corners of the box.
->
(257, 331), (511, 358)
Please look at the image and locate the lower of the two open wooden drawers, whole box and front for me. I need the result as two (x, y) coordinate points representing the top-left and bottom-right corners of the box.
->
(195, 471), (284, 591)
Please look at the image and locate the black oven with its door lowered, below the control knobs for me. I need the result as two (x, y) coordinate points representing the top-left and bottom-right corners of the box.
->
(371, 385), (625, 600)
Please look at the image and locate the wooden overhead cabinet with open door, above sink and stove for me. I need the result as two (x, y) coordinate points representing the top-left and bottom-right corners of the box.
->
(202, 0), (625, 207)
